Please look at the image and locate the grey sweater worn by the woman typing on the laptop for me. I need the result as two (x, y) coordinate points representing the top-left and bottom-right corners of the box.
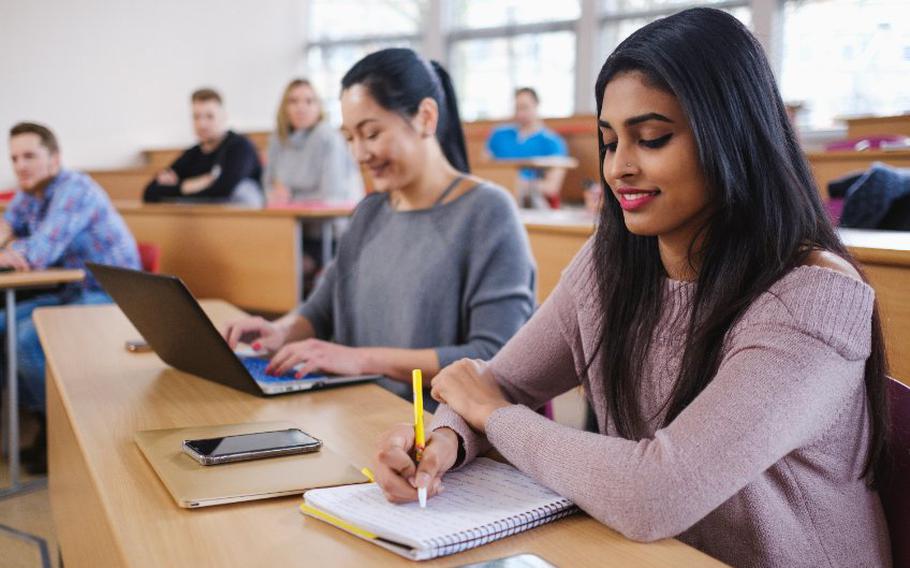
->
(299, 184), (535, 396)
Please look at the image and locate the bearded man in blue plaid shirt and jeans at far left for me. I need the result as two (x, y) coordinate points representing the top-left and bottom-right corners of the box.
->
(0, 122), (140, 473)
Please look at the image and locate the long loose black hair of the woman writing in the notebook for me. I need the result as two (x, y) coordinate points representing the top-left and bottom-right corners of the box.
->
(589, 8), (887, 485)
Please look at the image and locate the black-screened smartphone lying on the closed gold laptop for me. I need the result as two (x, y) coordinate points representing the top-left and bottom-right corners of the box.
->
(183, 428), (322, 465)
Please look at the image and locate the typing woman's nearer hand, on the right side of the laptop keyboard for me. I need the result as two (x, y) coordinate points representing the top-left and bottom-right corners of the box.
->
(265, 339), (365, 378)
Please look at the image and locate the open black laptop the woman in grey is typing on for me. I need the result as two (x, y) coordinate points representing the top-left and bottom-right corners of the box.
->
(86, 263), (380, 395)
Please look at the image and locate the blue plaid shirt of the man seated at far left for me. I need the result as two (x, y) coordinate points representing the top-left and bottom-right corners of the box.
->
(3, 170), (140, 296)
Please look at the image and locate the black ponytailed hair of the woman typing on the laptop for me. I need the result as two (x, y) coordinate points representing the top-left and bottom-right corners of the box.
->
(341, 47), (471, 173)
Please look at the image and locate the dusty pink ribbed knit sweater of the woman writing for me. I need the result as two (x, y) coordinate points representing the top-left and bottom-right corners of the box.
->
(433, 242), (891, 568)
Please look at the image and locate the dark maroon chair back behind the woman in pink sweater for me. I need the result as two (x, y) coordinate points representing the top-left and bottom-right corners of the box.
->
(880, 379), (910, 566)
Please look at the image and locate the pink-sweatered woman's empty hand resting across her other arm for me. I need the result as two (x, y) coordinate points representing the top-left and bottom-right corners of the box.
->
(431, 359), (512, 433)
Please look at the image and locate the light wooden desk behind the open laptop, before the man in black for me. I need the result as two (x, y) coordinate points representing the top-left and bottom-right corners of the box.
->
(115, 201), (351, 313)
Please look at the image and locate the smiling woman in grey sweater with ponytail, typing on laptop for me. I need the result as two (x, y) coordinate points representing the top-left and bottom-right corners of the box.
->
(224, 49), (535, 408)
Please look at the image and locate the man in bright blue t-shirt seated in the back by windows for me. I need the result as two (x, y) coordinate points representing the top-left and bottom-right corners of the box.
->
(487, 87), (569, 206)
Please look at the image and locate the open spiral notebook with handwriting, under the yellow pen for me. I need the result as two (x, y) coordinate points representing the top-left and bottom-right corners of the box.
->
(300, 458), (578, 560)
